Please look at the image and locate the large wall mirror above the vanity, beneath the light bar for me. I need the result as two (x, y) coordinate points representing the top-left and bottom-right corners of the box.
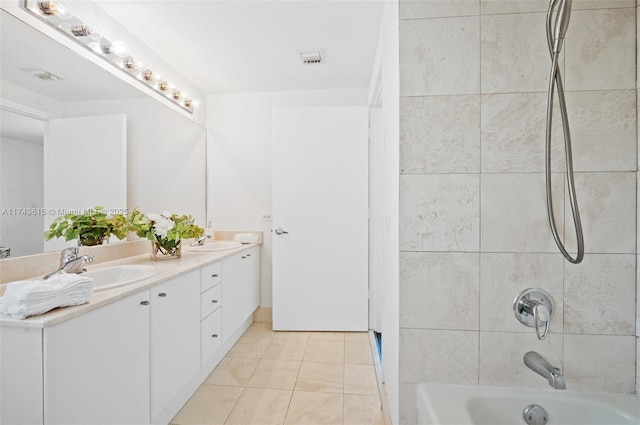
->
(0, 10), (206, 257)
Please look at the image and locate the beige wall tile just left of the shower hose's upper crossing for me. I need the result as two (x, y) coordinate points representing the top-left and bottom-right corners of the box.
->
(480, 13), (562, 93)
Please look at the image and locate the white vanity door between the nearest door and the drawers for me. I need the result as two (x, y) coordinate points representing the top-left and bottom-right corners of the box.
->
(149, 270), (200, 420)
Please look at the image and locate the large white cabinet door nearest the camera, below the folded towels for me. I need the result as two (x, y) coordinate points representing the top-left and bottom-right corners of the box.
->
(44, 291), (150, 424)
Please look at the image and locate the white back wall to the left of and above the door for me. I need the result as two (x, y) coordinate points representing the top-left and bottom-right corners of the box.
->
(206, 88), (367, 307)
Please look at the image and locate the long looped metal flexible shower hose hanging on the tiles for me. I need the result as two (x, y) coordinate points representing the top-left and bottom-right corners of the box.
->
(545, 2), (584, 264)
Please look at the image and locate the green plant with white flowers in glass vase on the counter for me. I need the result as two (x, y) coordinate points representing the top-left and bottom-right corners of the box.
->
(128, 207), (204, 260)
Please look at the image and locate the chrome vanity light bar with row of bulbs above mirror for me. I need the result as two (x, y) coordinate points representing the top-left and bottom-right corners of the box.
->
(21, 0), (199, 114)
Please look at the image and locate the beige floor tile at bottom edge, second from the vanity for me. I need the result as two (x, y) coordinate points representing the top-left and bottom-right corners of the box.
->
(225, 388), (292, 425)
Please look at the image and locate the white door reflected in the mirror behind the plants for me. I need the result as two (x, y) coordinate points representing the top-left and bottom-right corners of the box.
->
(43, 114), (127, 252)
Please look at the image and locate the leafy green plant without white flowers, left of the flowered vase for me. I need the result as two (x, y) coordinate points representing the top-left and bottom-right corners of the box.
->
(44, 206), (129, 246)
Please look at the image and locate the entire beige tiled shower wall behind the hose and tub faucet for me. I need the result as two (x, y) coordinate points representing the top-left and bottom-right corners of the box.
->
(400, 0), (638, 424)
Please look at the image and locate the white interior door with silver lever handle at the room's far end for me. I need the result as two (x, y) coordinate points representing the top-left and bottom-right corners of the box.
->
(273, 107), (368, 331)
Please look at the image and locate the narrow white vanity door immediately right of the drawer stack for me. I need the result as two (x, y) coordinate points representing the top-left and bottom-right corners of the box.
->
(222, 254), (247, 342)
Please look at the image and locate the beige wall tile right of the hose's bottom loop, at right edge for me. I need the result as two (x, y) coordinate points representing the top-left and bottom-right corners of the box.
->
(565, 172), (637, 253)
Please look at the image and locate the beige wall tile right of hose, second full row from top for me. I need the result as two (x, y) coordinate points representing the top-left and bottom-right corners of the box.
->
(568, 90), (638, 171)
